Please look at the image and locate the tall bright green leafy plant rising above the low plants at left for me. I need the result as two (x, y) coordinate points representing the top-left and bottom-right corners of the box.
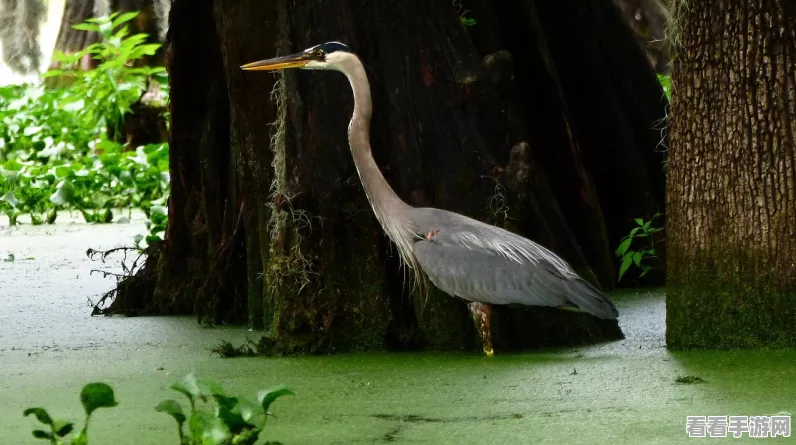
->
(43, 11), (166, 140)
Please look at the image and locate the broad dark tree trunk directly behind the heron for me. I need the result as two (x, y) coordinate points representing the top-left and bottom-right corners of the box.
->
(107, 0), (665, 353)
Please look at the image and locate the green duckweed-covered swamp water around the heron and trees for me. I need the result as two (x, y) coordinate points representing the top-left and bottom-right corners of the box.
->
(0, 217), (796, 445)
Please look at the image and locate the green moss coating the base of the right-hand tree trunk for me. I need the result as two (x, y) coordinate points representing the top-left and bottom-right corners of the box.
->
(666, 249), (796, 349)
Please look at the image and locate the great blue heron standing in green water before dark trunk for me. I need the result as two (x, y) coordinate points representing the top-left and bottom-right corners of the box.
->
(241, 42), (618, 356)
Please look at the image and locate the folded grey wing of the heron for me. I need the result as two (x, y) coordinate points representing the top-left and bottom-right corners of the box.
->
(413, 208), (618, 319)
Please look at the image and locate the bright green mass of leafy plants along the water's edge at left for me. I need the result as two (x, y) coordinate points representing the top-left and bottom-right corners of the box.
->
(0, 13), (170, 250)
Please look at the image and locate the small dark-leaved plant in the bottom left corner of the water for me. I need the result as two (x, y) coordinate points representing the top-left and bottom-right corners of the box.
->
(23, 383), (118, 445)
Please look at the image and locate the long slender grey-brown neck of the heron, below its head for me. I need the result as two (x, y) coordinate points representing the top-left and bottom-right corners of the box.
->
(344, 56), (409, 219)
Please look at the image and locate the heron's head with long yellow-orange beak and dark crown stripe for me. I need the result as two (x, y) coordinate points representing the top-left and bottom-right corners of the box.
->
(240, 42), (353, 71)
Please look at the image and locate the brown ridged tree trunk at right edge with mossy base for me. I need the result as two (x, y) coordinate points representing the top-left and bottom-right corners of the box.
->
(666, 0), (796, 348)
